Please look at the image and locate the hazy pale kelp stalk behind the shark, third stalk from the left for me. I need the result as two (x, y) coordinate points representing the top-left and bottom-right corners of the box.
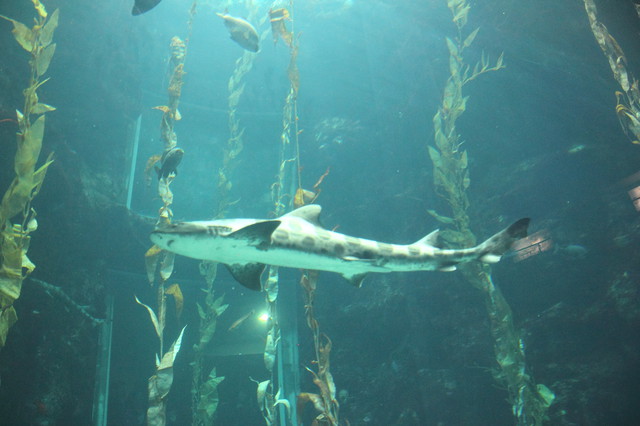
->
(191, 0), (266, 426)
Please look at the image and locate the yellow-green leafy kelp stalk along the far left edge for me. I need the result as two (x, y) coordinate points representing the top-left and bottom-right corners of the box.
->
(0, 0), (59, 348)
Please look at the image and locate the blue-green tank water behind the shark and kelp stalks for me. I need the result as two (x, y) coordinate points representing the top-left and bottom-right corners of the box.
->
(0, 0), (640, 426)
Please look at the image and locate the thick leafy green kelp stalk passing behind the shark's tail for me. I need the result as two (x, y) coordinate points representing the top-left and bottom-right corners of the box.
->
(428, 0), (555, 426)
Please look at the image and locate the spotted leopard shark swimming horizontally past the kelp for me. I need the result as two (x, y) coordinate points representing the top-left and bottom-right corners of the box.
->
(151, 204), (530, 290)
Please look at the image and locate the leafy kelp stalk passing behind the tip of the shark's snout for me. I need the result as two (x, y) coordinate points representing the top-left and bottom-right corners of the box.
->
(136, 1), (197, 426)
